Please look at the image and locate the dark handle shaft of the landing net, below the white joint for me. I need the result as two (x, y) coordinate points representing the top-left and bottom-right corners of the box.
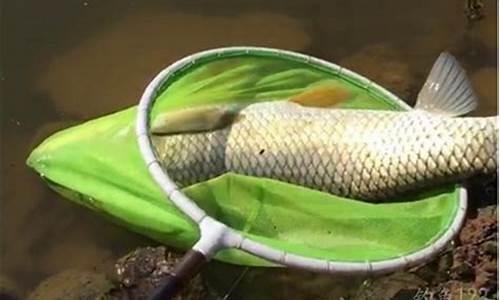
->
(149, 249), (208, 300)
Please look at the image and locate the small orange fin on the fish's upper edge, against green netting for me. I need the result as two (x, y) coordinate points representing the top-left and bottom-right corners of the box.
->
(289, 82), (351, 107)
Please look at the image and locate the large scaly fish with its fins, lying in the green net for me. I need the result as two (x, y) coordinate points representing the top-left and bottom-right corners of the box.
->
(151, 52), (498, 201)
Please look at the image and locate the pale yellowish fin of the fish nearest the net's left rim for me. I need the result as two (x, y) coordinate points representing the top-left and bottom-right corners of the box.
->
(151, 105), (242, 135)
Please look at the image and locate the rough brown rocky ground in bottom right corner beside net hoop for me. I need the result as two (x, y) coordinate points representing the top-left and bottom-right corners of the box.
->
(398, 204), (498, 300)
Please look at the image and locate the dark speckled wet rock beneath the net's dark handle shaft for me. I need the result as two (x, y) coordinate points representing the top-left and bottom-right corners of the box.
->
(115, 247), (208, 300)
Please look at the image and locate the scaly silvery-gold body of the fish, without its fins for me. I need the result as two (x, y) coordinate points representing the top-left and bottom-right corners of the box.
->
(153, 101), (498, 200)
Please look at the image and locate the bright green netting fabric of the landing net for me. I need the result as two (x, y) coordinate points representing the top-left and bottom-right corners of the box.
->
(27, 52), (458, 266)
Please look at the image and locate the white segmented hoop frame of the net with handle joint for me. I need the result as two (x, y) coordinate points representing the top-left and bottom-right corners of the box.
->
(136, 47), (467, 274)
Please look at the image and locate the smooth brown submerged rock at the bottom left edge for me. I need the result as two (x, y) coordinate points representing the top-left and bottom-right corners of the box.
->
(27, 270), (114, 300)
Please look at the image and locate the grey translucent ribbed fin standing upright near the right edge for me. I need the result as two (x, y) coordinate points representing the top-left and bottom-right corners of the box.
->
(415, 52), (477, 117)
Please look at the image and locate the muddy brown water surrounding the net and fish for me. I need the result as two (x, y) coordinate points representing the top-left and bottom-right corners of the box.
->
(0, 0), (497, 291)
